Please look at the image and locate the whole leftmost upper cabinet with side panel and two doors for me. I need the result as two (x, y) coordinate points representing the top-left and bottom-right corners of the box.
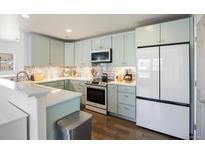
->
(28, 34), (65, 66)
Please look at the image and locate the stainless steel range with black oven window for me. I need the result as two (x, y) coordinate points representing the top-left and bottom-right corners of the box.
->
(85, 79), (107, 114)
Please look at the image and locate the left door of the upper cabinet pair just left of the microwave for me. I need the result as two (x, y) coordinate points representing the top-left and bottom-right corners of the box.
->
(75, 41), (83, 66)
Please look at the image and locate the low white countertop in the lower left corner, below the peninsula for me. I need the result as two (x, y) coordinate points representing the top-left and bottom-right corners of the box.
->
(0, 101), (27, 125)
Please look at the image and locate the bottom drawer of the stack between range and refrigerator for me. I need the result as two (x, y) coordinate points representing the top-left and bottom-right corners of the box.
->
(118, 104), (135, 119)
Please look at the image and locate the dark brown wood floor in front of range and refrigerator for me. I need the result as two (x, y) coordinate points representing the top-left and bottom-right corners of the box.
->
(82, 109), (176, 140)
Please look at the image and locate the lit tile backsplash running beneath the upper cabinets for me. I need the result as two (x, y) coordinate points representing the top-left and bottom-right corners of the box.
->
(25, 63), (136, 80)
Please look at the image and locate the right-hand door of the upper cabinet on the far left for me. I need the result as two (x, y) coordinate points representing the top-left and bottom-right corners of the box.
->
(50, 39), (65, 65)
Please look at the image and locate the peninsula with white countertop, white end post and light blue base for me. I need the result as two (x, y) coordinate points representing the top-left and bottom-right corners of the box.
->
(0, 78), (81, 140)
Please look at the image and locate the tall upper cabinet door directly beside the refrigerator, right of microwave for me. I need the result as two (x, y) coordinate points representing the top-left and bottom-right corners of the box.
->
(123, 31), (136, 66)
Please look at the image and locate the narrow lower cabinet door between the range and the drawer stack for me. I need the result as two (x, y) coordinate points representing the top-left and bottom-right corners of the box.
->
(108, 85), (117, 113)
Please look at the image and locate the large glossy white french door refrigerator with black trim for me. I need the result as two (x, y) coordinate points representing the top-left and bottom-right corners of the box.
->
(136, 44), (190, 139)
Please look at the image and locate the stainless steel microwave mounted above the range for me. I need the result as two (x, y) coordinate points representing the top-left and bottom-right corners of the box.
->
(90, 49), (112, 63)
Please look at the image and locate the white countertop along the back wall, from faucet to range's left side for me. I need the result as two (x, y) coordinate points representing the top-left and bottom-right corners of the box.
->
(29, 77), (91, 84)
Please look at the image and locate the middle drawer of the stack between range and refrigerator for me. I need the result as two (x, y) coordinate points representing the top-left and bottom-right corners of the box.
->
(118, 92), (135, 106)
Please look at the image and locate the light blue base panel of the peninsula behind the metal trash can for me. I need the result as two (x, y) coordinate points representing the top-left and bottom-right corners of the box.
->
(46, 97), (80, 140)
